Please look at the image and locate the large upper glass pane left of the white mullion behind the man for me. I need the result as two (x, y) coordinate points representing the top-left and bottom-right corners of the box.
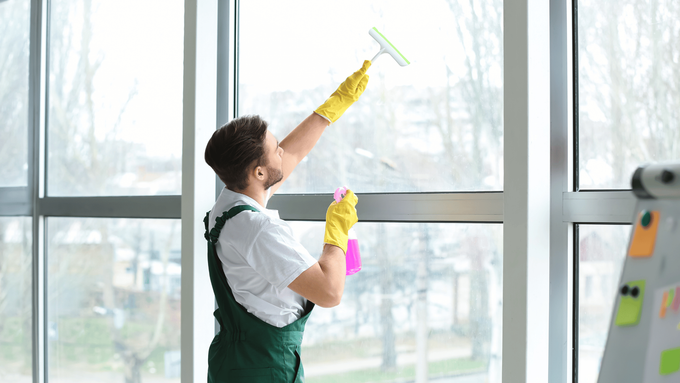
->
(47, 0), (184, 196)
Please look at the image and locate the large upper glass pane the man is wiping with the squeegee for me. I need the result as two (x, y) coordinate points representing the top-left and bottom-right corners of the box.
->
(238, 0), (503, 193)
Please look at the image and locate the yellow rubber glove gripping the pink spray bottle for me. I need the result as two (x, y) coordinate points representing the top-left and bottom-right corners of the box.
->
(323, 189), (359, 253)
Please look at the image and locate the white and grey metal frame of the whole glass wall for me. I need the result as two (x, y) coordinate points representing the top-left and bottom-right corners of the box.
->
(0, 0), (636, 383)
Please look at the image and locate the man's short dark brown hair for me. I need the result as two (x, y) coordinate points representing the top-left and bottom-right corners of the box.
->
(205, 116), (268, 190)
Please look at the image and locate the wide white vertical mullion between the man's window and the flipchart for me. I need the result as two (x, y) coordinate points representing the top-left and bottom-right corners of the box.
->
(502, 0), (554, 382)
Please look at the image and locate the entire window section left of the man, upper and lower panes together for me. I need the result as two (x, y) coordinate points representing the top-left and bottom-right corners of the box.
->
(0, 0), (184, 383)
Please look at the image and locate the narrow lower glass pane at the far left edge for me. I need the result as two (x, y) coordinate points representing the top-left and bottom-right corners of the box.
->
(0, 218), (33, 383)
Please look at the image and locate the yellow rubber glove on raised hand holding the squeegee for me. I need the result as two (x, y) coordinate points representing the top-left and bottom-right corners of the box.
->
(314, 60), (371, 124)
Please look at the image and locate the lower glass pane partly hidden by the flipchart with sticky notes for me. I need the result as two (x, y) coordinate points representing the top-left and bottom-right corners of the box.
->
(578, 225), (631, 383)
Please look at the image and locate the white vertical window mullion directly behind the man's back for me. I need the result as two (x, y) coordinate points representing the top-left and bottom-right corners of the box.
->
(181, 0), (220, 383)
